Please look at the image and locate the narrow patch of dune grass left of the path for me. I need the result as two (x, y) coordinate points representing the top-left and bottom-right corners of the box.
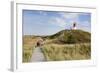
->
(22, 36), (36, 63)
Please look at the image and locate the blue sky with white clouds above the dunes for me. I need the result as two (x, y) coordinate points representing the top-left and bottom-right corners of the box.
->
(23, 10), (91, 35)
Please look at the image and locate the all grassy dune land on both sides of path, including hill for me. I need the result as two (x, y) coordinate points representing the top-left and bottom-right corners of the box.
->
(23, 30), (91, 62)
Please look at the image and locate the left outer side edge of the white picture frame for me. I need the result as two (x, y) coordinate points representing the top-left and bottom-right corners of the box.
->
(11, 1), (17, 71)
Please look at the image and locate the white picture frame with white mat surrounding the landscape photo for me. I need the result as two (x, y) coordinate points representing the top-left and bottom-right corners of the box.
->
(11, 2), (97, 71)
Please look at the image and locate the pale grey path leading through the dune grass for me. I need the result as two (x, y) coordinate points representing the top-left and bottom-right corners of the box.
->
(31, 47), (45, 62)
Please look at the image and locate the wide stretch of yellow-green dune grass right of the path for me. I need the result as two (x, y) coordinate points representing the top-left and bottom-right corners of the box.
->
(42, 43), (91, 61)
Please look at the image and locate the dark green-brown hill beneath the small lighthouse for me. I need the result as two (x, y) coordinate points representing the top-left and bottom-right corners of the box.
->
(42, 30), (91, 44)
